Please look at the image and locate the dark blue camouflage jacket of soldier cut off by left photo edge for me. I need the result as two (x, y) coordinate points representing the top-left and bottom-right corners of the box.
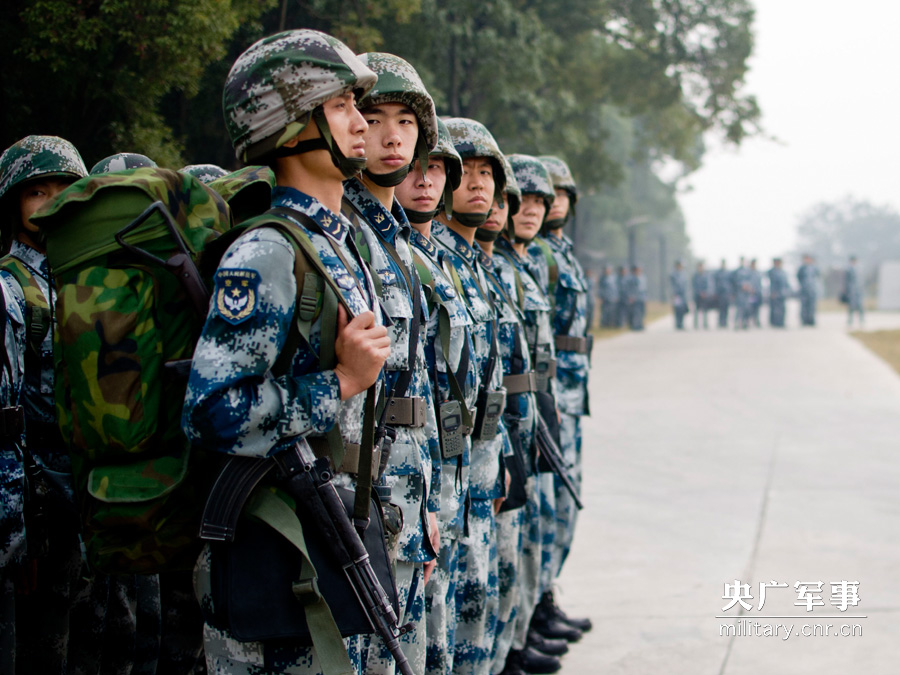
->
(0, 277), (25, 569)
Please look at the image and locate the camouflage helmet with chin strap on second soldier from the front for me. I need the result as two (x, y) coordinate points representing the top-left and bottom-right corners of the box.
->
(357, 52), (438, 187)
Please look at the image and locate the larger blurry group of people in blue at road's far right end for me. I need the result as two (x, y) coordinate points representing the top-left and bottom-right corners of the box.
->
(669, 255), (864, 330)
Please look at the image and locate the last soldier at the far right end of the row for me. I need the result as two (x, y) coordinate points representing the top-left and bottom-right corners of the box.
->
(528, 156), (593, 642)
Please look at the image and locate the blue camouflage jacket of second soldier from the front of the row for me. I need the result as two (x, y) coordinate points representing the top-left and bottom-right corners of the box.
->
(343, 179), (441, 562)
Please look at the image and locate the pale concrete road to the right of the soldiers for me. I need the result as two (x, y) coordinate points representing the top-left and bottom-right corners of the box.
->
(558, 312), (900, 675)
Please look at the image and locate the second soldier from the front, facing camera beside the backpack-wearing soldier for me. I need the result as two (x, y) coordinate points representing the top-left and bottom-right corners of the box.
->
(343, 53), (441, 675)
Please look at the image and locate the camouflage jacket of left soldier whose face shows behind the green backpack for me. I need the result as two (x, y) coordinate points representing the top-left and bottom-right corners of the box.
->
(0, 241), (64, 474)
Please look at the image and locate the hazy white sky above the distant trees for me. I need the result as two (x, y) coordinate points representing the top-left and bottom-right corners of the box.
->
(679, 0), (900, 270)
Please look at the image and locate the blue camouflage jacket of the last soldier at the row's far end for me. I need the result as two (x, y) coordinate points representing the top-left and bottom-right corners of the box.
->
(526, 235), (592, 415)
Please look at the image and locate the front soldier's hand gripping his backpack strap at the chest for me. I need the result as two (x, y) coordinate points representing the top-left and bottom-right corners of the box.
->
(334, 305), (391, 401)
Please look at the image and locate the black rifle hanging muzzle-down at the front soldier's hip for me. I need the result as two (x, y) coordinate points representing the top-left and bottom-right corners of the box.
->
(274, 440), (413, 675)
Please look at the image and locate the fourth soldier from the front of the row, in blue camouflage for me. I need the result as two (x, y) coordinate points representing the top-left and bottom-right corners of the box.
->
(428, 118), (511, 674)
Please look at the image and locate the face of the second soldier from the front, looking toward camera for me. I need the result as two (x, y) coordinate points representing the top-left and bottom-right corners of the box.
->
(362, 103), (419, 175)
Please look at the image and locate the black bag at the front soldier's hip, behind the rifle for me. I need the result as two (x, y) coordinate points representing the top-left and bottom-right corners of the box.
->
(205, 487), (400, 646)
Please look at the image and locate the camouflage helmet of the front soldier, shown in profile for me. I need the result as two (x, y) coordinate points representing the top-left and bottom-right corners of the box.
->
(229, 29), (378, 164)
